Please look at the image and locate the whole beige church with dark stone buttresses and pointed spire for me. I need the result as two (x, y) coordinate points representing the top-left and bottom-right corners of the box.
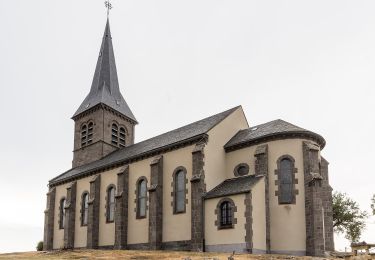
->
(43, 17), (334, 256)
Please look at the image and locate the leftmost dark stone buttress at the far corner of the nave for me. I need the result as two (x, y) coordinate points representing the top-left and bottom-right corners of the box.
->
(43, 188), (56, 251)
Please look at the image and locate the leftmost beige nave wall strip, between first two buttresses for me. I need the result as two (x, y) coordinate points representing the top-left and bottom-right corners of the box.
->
(53, 184), (69, 249)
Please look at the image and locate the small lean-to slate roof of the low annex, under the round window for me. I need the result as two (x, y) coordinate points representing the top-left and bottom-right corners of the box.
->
(204, 175), (263, 199)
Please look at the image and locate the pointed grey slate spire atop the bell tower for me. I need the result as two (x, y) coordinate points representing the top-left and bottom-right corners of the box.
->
(73, 19), (137, 123)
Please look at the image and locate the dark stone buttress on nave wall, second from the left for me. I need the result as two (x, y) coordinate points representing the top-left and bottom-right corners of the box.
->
(64, 181), (77, 249)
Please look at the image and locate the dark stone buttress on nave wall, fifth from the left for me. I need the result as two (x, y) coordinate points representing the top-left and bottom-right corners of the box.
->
(148, 156), (163, 250)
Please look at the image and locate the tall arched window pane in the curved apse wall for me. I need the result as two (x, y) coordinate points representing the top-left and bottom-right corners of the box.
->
(278, 158), (294, 204)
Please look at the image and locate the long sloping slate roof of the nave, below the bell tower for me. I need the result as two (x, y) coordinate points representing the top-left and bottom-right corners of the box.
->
(50, 106), (239, 185)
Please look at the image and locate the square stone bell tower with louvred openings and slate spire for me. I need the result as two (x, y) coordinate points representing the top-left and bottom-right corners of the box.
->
(72, 19), (137, 167)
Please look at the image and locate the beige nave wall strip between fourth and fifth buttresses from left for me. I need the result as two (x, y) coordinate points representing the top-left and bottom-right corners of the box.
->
(128, 158), (152, 244)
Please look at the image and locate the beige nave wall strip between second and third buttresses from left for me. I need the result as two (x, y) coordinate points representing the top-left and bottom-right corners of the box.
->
(74, 177), (92, 248)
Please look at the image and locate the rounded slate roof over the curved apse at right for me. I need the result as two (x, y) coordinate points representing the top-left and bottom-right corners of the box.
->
(224, 119), (326, 152)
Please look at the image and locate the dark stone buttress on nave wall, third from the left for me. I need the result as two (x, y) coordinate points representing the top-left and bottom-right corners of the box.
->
(87, 174), (100, 249)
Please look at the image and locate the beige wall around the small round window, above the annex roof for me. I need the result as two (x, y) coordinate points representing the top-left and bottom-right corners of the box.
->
(226, 146), (257, 179)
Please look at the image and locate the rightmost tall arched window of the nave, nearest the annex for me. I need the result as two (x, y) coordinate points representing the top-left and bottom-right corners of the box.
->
(173, 169), (186, 213)
